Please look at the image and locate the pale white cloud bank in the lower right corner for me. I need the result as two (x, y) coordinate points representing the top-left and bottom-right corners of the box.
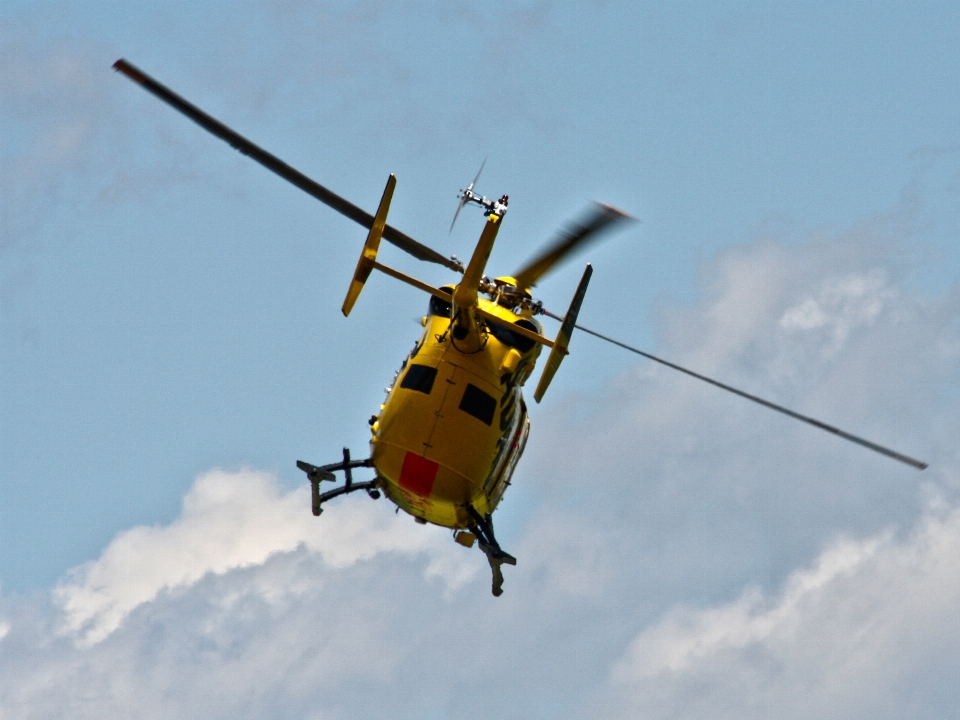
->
(611, 498), (960, 718)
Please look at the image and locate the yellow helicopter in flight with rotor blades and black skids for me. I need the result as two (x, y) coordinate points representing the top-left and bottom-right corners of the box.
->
(113, 59), (927, 596)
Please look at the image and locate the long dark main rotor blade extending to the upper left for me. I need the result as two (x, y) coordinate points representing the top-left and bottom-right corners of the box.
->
(113, 58), (463, 272)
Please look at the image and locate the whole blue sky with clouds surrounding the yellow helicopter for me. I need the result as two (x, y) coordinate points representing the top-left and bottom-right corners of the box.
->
(0, 0), (960, 720)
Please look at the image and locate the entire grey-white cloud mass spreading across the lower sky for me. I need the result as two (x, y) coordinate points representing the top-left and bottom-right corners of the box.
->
(0, 210), (960, 719)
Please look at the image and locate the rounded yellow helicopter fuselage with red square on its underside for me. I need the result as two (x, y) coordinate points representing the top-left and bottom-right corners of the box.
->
(370, 288), (542, 529)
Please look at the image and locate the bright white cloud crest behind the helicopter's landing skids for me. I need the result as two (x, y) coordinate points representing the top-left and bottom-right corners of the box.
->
(54, 470), (473, 644)
